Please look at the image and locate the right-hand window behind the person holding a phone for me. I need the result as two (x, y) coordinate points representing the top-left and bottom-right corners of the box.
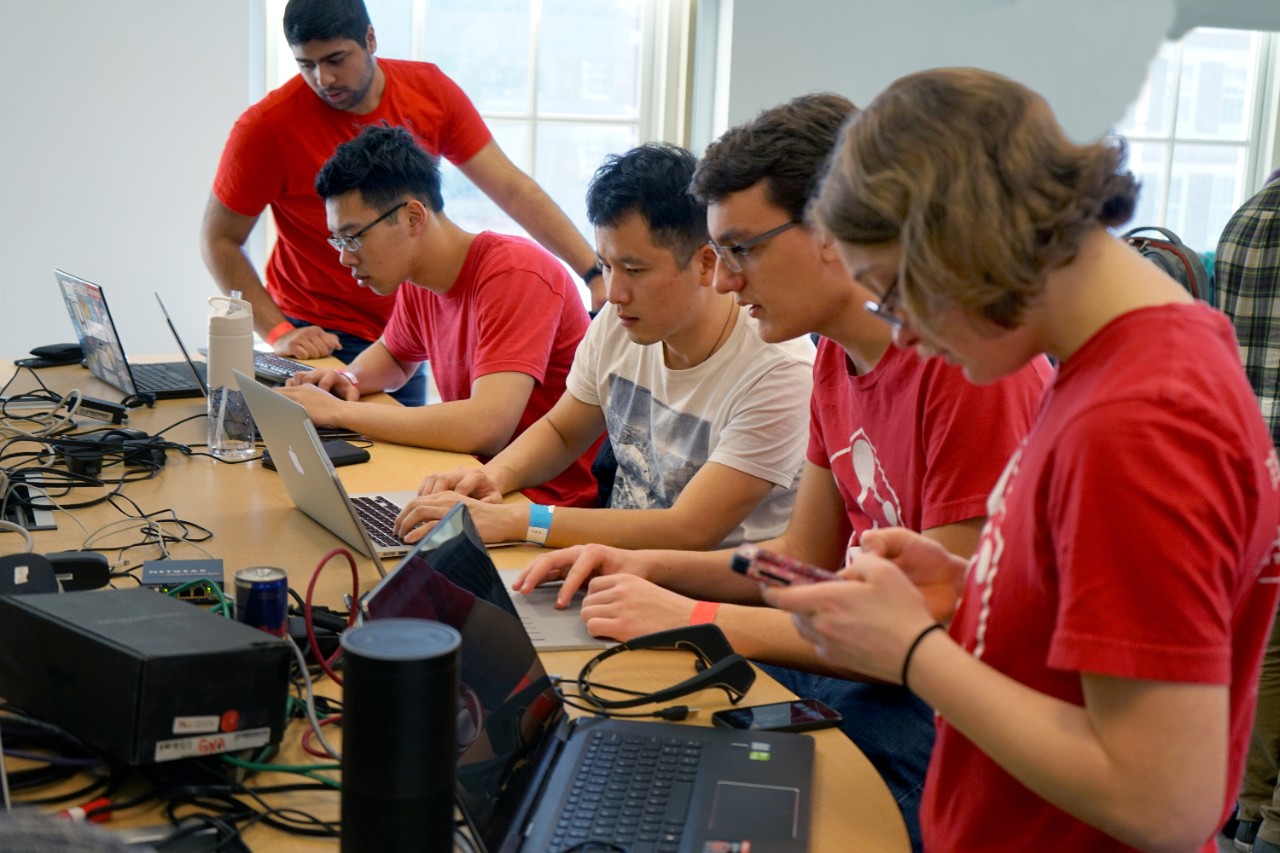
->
(1116, 29), (1280, 252)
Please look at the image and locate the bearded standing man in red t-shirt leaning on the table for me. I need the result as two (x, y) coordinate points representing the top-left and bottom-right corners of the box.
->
(201, 0), (604, 403)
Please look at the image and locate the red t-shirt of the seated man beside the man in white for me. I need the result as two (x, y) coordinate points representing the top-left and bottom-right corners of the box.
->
(383, 232), (599, 506)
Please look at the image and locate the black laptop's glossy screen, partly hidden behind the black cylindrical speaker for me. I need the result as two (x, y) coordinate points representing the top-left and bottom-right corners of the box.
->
(362, 503), (563, 850)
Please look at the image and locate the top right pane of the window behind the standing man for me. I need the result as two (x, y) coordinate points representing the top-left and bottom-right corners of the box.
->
(538, 0), (644, 119)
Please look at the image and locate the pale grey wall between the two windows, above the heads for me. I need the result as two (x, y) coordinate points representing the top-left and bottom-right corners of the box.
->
(721, 0), (1172, 140)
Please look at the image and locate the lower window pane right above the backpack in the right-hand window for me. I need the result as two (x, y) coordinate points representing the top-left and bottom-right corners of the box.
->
(1166, 143), (1247, 252)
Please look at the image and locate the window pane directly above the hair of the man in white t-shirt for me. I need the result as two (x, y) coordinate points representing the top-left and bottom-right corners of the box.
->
(534, 122), (639, 239)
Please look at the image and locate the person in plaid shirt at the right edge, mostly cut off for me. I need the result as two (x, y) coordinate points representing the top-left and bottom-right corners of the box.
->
(1213, 169), (1280, 853)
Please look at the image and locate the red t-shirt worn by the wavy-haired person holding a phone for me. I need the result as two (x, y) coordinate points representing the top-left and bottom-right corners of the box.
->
(920, 304), (1280, 853)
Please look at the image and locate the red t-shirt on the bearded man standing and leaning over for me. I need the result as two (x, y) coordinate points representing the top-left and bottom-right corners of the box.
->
(214, 59), (493, 341)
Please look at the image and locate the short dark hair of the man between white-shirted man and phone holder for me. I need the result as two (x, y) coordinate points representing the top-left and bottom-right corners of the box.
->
(691, 92), (858, 222)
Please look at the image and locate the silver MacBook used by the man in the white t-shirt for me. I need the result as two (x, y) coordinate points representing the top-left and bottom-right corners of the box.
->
(234, 370), (417, 574)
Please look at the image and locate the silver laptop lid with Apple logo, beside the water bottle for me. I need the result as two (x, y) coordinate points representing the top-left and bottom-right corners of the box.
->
(233, 370), (385, 575)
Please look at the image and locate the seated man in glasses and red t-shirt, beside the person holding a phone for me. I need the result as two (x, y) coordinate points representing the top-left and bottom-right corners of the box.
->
(506, 95), (1050, 840)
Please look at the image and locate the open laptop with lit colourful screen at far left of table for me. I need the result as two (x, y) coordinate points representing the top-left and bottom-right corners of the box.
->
(54, 269), (202, 400)
